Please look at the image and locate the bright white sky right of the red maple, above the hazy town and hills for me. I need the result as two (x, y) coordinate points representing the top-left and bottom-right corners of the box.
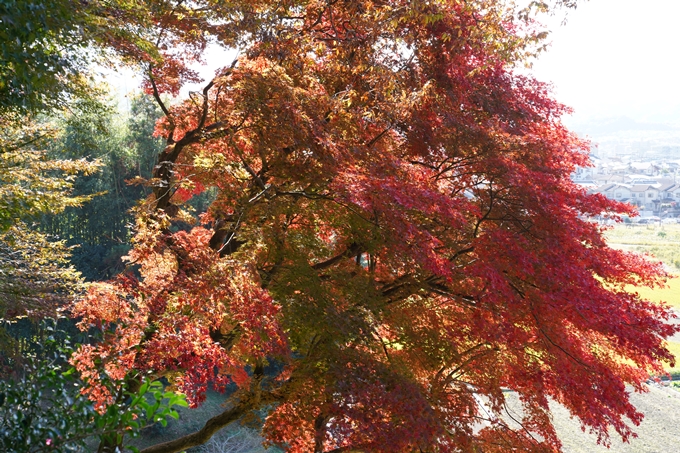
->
(533, 0), (680, 123)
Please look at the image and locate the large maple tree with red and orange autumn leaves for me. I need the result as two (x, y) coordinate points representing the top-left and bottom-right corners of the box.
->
(65, 0), (676, 453)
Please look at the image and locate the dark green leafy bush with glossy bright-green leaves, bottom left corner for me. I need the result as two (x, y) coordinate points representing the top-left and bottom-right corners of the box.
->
(0, 337), (187, 453)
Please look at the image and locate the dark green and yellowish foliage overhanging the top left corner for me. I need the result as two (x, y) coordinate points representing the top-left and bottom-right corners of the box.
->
(0, 0), (169, 116)
